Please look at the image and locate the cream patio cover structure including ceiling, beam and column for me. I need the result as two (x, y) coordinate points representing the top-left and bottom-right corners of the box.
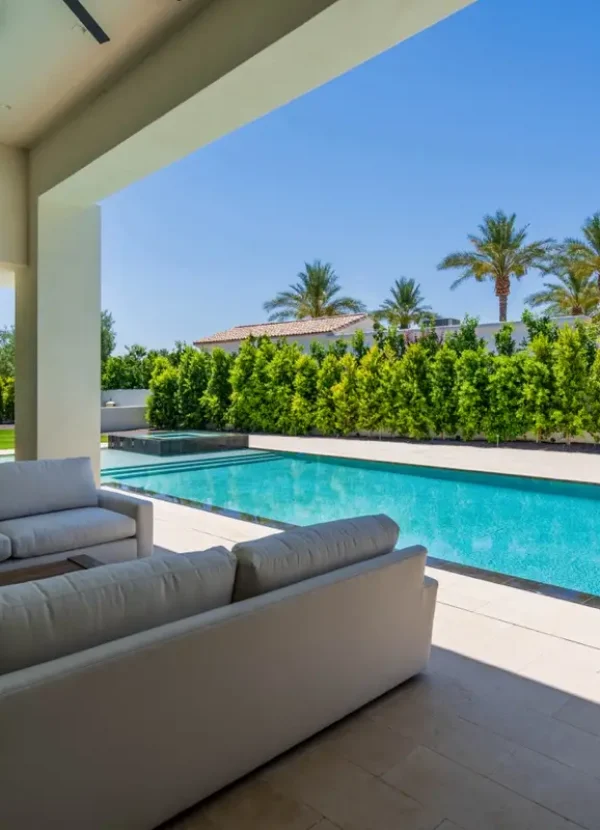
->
(0, 0), (471, 469)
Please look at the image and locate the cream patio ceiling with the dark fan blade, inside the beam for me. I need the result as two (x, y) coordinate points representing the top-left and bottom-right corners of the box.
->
(0, 0), (211, 147)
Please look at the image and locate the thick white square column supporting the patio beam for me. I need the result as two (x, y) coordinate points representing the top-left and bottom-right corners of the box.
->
(16, 196), (100, 473)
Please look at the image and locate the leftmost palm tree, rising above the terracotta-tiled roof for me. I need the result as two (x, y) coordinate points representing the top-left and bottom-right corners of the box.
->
(263, 259), (366, 321)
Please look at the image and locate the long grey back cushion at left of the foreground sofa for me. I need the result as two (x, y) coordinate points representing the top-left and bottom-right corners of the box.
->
(0, 548), (236, 674)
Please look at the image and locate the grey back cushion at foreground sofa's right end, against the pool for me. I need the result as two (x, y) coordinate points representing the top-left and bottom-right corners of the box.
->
(232, 515), (399, 602)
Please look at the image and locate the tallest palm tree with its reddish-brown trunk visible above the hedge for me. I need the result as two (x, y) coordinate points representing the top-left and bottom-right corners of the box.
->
(438, 210), (553, 323)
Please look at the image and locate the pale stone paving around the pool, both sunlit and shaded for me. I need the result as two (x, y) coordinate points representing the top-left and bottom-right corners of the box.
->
(104, 436), (600, 830)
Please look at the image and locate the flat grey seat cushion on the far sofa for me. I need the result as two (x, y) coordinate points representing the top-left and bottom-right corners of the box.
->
(0, 507), (136, 559)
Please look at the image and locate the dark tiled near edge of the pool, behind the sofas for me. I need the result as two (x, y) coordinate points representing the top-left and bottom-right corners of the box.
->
(102, 481), (600, 610)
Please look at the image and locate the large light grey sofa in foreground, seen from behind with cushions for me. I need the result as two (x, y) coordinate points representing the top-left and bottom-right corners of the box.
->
(0, 517), (437, 830)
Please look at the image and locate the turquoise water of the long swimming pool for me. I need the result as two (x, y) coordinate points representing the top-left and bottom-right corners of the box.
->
(105, 451), (600, 594)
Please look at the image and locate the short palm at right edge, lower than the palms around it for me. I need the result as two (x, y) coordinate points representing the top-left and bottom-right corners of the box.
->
(525, 253), (600, 316)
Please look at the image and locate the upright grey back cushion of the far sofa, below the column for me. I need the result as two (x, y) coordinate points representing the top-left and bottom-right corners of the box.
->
(0, 458), (98, 521)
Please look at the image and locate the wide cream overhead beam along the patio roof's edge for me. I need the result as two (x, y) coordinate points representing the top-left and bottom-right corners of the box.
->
(31, 0), (473, 204)
